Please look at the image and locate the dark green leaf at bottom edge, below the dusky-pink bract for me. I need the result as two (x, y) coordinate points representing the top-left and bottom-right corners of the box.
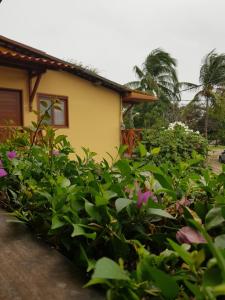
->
(149, 266), (179, 299)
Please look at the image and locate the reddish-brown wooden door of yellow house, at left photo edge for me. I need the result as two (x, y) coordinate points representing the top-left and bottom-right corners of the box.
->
(0, 89), (23, 126)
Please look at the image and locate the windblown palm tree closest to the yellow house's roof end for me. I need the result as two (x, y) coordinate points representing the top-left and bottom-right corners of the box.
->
(127, 48), (180, 125)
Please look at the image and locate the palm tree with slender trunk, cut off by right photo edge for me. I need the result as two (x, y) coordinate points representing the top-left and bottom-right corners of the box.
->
(180, 50), (225, 138)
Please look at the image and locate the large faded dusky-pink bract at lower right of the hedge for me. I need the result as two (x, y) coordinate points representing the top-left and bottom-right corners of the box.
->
(176, 226), (206, 244)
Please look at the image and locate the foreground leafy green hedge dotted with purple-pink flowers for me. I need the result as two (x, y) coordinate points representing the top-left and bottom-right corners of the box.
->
(0, 128), (225, 300)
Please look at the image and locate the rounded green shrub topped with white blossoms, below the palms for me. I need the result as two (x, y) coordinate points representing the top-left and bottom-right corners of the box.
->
(143, 122), (208, 164)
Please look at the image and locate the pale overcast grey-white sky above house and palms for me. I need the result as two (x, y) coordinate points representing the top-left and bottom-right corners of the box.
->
(0, 0), (225, 100)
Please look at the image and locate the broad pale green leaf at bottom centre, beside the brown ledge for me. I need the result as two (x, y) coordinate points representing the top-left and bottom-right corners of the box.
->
(92, 257), (130, 280)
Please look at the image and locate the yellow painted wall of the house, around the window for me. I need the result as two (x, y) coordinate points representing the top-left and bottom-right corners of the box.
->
(0, 67), (121, 159)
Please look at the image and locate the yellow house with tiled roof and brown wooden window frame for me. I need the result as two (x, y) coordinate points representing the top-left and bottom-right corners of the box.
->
(0, 36), (155, 157)
